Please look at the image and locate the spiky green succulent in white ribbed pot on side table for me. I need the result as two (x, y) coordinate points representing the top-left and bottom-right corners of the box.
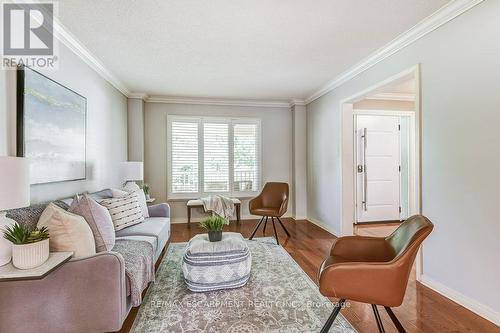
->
(4, 223), (49, 269)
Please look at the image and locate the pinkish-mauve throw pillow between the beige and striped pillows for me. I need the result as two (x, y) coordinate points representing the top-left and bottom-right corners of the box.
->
(69, 195), (115, 252)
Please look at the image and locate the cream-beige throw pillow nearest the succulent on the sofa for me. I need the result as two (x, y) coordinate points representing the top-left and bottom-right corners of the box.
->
(37, 203), (95, 258)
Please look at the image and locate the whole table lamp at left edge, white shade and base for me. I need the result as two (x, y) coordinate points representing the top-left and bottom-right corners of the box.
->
(0, 156), (30, 266)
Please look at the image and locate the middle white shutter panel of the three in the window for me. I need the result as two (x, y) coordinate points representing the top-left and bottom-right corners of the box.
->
(203, 121), (229, 193)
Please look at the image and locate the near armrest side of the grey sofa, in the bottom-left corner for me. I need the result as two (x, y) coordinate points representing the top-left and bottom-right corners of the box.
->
(0, 252), (127, 332)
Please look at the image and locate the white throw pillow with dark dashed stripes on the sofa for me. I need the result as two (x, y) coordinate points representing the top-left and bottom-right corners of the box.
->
(100, 192), (144, 231)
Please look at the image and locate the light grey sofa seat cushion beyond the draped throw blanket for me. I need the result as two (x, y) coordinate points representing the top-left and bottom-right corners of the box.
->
(116, 217), (170, 258)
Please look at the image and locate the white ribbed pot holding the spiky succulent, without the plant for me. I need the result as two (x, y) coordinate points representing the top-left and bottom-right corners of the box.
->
(12, 239), (49, 269)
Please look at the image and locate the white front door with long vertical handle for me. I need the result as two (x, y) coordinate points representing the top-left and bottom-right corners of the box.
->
(356, 115), (400, 222)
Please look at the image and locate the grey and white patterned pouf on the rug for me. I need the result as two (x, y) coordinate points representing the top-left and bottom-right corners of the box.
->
(182, 232), (252, 292)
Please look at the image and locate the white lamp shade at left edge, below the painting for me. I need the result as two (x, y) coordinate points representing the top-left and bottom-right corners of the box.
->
(0, 156), (30, 211)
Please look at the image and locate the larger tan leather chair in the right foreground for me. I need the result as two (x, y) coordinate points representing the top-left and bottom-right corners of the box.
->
(318, 215), (434, 333)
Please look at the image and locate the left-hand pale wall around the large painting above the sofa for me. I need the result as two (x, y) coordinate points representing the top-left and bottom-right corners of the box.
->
(0, 44), (127, 203)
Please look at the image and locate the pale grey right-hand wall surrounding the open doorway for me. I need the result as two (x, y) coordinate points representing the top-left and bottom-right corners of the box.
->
(307, 1), (500, 324)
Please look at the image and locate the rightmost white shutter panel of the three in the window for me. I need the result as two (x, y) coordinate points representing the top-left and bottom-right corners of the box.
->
(232, 122), (261, 192)
